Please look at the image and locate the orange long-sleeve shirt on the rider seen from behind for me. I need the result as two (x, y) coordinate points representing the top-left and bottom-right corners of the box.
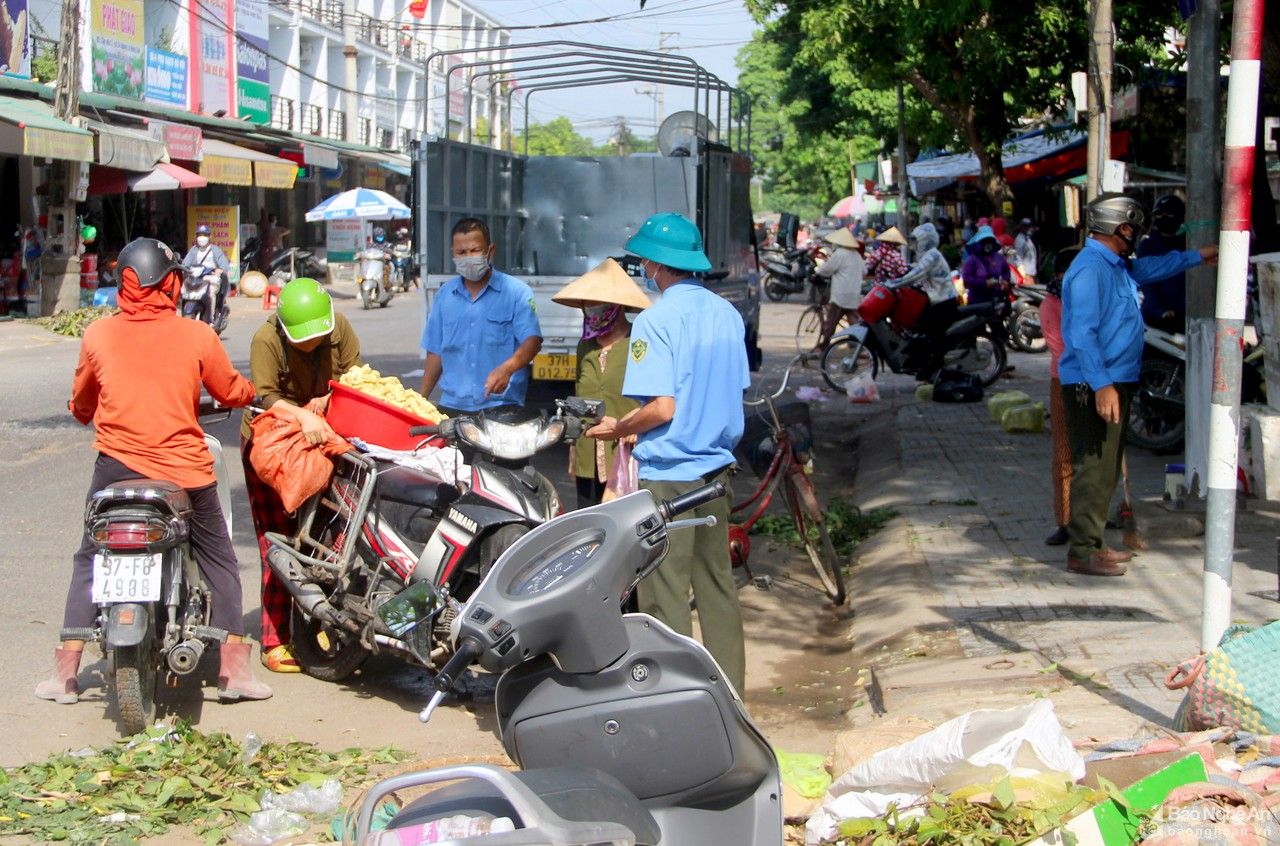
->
(70, 295), (253, 488)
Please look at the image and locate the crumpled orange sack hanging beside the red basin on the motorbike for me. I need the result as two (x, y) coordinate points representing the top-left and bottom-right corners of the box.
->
(248, 411), (355, 513)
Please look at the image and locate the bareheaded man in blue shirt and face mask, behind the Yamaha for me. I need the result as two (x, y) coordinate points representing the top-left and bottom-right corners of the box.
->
(422, 218), (543, 417)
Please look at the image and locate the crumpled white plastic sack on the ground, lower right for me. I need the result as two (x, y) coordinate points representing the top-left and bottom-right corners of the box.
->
(805, 699), (1084, 846)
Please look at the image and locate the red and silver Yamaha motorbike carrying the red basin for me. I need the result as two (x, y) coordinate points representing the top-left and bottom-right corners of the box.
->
(265, 397), (603, 681)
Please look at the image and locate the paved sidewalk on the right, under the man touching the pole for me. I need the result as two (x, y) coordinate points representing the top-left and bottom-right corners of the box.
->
(849, 345), (1280, 735)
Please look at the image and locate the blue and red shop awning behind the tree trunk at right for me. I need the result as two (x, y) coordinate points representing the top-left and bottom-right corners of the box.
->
(906, 128), (1129, 196)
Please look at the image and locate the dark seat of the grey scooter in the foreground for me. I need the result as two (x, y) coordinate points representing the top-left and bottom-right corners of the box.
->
(388, 767), (662, 846)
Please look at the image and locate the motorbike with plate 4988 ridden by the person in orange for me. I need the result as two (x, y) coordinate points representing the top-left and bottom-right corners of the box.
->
(63, 398), (232, 735)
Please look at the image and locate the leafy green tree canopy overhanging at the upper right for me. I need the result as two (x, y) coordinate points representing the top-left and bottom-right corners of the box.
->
(746, 0), (1176, 207)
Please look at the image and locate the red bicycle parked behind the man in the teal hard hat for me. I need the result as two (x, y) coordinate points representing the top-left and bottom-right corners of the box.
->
(728, 356), (845, 605)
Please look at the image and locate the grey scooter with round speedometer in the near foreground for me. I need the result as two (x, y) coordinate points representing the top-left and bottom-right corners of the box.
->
(346, 483), (783, 846)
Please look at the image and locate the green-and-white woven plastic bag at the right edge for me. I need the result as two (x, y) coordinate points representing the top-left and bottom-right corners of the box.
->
(1165, 622), (1280, 735)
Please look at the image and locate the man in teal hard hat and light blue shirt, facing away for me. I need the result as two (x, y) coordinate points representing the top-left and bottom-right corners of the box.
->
(586, 212), (751, 694)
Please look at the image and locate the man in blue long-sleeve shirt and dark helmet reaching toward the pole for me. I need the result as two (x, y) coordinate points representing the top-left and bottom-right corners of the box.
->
(1059, 193), (1217, 576)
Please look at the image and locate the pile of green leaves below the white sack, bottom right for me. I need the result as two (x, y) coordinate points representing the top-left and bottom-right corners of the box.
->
(823, 777), (1105, 846)
